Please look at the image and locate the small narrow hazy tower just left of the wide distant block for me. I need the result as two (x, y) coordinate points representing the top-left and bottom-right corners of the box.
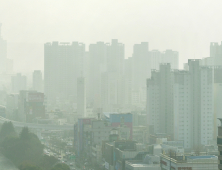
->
(32, 70), (43, 92)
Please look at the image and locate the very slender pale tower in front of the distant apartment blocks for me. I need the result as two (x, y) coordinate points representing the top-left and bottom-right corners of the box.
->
(77, 77), (86, 117)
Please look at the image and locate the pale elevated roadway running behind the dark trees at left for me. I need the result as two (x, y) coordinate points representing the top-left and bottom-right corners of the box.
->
(0, 116), (74, 130)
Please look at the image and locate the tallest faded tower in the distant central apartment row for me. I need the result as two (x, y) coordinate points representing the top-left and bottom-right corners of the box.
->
(101, 39), (125, 111)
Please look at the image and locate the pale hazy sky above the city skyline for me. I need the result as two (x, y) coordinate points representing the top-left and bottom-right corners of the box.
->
(0, 0), (222, 70)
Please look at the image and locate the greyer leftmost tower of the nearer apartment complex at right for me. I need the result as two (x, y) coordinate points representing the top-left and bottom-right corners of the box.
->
(147, 64), (174, 139)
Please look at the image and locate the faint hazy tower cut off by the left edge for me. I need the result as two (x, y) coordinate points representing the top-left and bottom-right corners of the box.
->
(0, 23), (7, 73)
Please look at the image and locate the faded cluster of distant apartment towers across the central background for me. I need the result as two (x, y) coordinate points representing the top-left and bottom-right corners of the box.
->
(44, 39), (179, 116)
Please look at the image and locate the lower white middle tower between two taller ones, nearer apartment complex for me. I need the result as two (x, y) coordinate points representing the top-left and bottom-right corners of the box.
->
(173, 70), (193, 148)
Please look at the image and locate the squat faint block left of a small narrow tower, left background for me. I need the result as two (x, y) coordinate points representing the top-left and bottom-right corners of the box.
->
(11, 73), (27, 93)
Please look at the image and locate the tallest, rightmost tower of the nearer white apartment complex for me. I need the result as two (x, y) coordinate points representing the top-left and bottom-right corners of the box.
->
(188, 60), (214, 148)
